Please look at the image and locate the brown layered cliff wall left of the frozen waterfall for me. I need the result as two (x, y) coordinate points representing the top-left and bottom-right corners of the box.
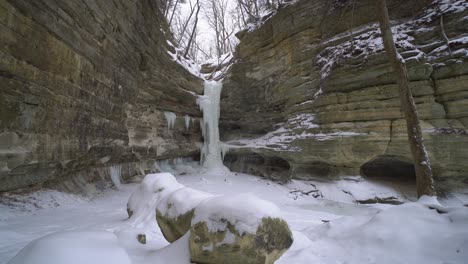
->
(0, 0), (202, 191)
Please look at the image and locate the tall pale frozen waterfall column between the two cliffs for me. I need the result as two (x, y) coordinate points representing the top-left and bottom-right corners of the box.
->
(197, 81), (228, 169)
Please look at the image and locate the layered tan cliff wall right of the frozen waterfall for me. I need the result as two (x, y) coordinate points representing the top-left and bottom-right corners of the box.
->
(220, 0), (468, 188)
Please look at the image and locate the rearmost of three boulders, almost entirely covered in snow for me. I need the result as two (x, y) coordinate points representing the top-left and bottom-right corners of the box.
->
(127, 173), (184, 220)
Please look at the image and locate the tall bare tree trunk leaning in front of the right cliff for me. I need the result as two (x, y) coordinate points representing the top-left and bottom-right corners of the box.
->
(378, 0), (435, 197)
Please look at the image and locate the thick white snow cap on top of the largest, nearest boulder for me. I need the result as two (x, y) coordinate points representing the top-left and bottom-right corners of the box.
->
(192, 193), (281, 235)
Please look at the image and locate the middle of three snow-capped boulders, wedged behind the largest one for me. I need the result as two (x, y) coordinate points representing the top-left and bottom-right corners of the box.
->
(156, 188), (213, 242)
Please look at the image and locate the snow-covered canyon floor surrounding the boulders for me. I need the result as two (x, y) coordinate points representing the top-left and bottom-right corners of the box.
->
(0, 168), (468, 264)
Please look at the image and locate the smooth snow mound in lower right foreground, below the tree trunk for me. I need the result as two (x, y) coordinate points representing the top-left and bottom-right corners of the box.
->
(277, 203), (468, 264)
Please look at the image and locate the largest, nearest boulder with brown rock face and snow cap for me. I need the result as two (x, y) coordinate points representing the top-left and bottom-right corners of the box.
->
(189, 194), (293, 264)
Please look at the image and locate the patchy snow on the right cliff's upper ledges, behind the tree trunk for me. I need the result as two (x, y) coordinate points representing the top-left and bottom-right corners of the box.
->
(316, 0), (468, 79)
